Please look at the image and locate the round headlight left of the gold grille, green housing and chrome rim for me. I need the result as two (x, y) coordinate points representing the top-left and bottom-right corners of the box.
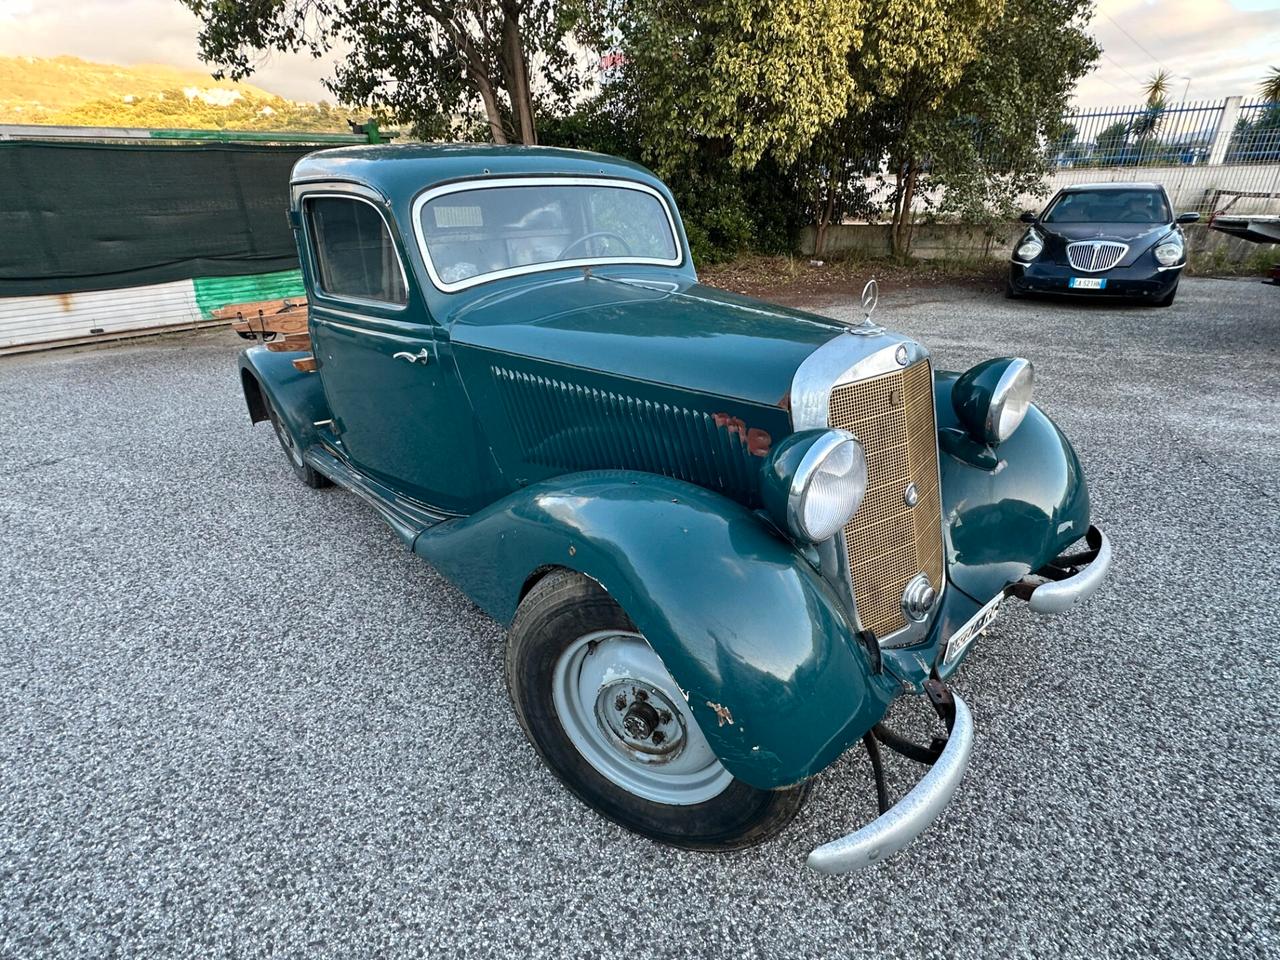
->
(762, 430), (867, 543)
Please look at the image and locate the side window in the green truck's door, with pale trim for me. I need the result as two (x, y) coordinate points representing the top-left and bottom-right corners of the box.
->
(305, 197), (408, 306)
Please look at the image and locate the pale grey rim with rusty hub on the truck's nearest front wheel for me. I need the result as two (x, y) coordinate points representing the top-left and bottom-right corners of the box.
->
(552, 630), (733, 806)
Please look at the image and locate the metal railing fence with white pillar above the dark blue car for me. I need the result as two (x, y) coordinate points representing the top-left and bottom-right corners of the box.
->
(1048, 97), (1280, 169)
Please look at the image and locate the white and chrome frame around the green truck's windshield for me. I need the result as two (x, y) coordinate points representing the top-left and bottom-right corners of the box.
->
(410, 177), (685, 293)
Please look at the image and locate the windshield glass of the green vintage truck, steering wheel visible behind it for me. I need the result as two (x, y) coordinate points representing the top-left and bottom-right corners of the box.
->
(417, 179), (681, 291)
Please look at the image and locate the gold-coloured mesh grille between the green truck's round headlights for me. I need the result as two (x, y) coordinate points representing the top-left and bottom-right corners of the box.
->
(829, 360), (942, 637)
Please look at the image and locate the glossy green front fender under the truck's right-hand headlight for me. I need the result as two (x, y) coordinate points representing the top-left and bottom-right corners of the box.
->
(934, 372), (1089, 603)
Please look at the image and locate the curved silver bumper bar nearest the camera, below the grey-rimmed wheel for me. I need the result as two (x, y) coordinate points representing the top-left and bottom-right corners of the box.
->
(808, 692), (973, 873)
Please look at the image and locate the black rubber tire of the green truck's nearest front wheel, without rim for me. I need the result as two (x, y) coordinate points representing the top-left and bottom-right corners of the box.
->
(506, 570), (809, 851)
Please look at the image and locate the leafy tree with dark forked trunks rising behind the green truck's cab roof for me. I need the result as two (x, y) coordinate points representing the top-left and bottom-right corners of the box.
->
(180, 0), (589, 143)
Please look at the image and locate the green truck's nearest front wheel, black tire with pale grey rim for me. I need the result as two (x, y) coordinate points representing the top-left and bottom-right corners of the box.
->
(506, 571), (809, 850)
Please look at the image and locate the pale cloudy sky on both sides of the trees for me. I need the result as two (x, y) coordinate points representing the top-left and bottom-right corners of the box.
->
(0, 0), (1280, 106)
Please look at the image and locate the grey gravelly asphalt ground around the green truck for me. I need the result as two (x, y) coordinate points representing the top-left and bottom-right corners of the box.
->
(0, 273), (1280, 960)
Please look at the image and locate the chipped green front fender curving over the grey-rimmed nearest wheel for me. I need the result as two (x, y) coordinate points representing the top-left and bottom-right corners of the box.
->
(413, 471), (897, 788)
